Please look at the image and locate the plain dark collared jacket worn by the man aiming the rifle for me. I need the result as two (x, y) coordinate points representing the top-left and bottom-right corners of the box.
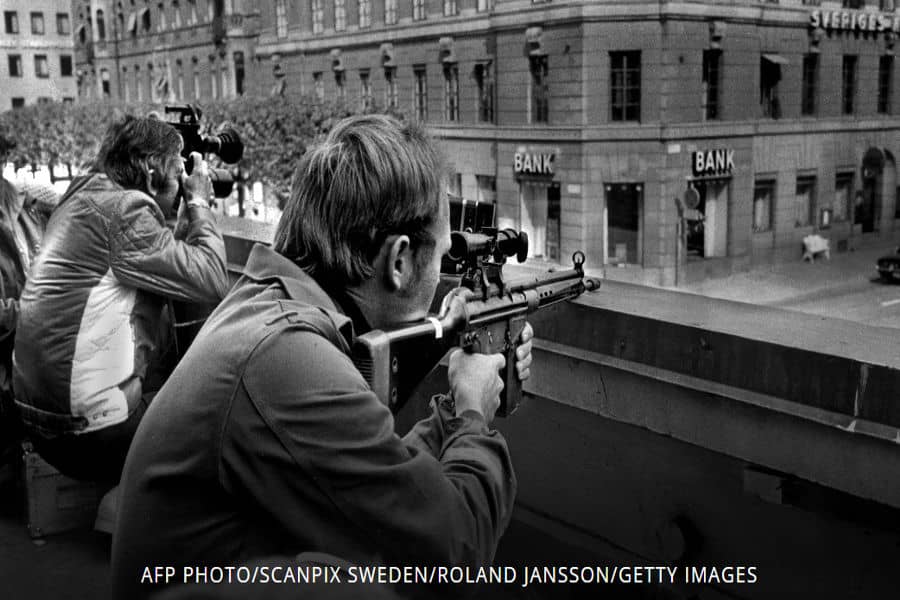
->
(112, 245), (516, 599)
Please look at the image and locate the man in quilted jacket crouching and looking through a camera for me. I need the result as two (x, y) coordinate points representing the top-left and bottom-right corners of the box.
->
(13, 116), (228, 483)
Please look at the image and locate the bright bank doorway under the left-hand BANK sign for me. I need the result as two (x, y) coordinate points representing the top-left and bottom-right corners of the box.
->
(519, 181), (562, 261)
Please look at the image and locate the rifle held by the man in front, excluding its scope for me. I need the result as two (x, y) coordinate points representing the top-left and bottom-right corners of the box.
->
(353, 255), (600, 416)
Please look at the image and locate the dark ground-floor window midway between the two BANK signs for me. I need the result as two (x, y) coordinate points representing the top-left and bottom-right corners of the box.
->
(606, 183), (644, 264)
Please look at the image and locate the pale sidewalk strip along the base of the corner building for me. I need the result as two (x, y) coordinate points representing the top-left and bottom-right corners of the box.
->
(667, 242), (896, 306)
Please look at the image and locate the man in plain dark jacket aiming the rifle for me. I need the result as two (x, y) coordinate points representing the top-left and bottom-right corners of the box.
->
(112, 115), (533, 598)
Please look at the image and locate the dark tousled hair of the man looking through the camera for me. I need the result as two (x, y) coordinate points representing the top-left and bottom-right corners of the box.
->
(93, 115), (182, 190)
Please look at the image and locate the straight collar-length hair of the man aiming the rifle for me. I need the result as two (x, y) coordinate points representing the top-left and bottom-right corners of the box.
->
(273, 115), (446, 288)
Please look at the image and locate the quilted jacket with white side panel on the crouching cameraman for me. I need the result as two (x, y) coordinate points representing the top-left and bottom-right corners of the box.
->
(13, 173), (228, 437)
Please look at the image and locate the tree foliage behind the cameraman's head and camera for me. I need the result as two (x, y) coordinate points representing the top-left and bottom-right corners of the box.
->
(0, 96), (400, 198)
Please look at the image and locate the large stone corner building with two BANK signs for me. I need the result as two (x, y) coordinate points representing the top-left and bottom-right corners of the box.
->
(251, 0), (900, 285)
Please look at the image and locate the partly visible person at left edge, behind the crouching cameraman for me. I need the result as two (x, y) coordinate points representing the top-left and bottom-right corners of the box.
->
(0, 135), (59, 464)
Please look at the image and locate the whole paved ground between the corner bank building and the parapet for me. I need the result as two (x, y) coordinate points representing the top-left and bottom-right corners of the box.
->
(670, 243), (900, 328)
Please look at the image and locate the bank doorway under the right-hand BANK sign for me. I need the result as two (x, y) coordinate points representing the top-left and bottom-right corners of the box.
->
(685, 179), (730, 259)
